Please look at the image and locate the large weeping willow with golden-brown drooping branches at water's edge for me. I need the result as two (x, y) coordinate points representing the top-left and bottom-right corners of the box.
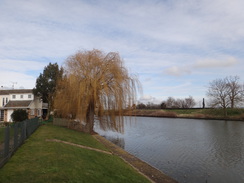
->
(55, 49), (140, 133)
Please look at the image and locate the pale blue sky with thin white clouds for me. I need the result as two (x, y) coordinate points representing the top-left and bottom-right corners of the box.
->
(0, 0), (244, 106)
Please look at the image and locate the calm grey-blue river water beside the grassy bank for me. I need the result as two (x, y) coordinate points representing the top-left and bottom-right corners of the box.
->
(95, 117), (244, 183)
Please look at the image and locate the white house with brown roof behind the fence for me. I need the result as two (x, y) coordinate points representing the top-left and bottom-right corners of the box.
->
(0, 89), (47, 122)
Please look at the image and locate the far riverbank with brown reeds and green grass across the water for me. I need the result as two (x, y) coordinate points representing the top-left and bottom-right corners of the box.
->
(124, 108), (244, 121)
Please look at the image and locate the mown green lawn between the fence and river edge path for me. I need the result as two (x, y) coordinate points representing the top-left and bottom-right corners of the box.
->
(0, 124), (149, 183)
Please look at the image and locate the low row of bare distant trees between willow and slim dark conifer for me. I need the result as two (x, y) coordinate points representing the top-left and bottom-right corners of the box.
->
(136, 96), (196, 109)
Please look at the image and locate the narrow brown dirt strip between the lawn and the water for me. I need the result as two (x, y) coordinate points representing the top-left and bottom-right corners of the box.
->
(93, 135), (177, 183)
